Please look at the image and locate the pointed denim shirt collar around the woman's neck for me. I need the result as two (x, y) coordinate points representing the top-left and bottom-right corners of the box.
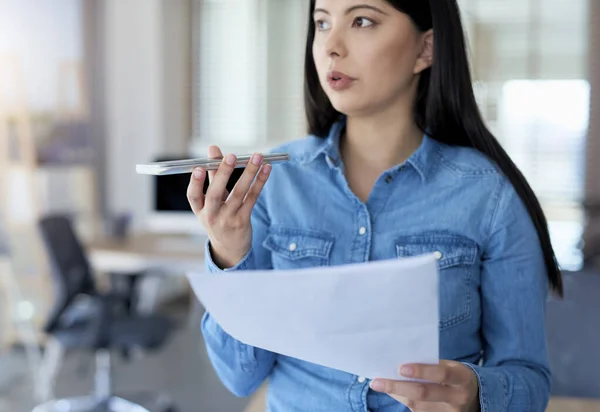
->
(302, 119), (441, 181)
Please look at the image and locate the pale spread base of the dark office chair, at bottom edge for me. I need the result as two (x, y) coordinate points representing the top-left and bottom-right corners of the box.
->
(32, 396), (152, 412)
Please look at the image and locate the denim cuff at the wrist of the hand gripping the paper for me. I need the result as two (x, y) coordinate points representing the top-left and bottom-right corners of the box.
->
(463, 362), (508, 412)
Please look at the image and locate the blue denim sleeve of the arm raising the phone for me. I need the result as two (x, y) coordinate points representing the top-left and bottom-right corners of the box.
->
(201, 195), (276, 397)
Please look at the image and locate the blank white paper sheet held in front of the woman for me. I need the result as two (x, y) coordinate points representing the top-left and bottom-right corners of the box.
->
(188, 255), (439, 380)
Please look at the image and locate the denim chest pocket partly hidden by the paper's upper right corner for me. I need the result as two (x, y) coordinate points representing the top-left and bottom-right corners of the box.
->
(396, 234), (477, 330)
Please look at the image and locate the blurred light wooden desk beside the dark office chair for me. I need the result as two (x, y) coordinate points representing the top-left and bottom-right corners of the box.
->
(87, 233), (205, 275)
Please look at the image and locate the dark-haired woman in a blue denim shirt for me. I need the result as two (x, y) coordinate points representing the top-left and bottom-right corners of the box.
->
(188, 0), (562, 412)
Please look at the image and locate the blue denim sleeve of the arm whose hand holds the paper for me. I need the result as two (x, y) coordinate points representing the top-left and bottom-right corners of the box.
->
(468, 181), (551, 412)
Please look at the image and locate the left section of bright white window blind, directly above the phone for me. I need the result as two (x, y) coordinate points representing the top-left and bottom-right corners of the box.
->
(194, 0), (266, 146)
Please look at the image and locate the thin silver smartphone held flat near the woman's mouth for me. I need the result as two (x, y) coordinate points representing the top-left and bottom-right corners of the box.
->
(135, 153), (290, 176)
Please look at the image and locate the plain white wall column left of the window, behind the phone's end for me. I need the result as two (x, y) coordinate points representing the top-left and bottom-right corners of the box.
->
(104, 0), (191, 228)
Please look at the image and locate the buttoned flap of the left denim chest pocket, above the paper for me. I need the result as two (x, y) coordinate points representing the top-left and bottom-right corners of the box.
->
(263, 227), (333, 260)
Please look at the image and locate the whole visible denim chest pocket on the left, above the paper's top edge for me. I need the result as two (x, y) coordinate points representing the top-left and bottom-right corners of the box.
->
(263, 227), (334, 269)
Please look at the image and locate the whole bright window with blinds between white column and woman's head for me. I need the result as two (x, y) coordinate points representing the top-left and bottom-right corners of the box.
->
(192, 0), (309, 154)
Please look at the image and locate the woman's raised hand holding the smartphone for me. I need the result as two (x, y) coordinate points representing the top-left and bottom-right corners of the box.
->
(187, 146), (271, 268)
